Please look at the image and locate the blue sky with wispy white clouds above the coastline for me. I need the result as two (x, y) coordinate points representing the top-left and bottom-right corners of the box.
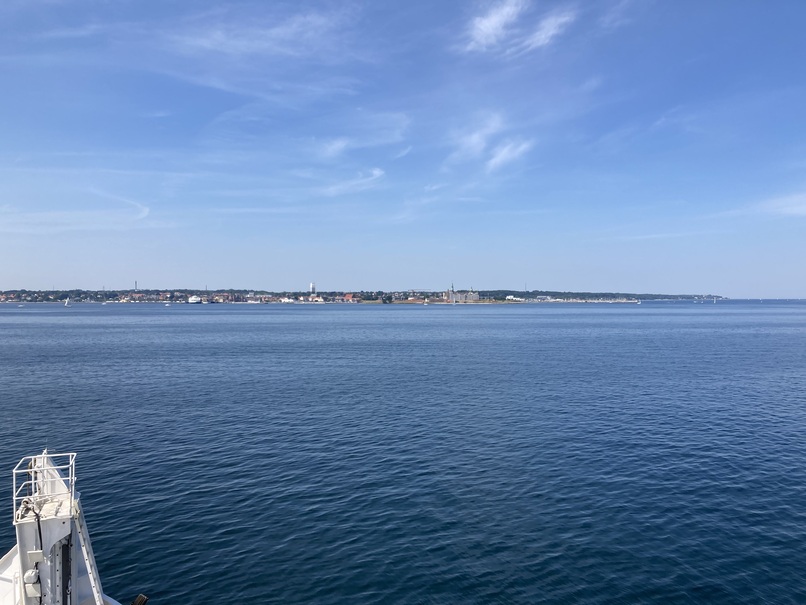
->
(0, 0), (806, 298)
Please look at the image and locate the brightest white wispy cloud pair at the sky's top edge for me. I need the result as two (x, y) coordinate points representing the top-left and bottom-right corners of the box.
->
(464, 0), (576, 55)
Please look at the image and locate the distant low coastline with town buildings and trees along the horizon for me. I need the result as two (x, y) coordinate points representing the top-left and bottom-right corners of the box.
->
(0, 288), (726, 304)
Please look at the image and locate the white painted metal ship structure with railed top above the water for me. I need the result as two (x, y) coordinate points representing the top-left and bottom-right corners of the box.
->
(0, 450), (120, 605)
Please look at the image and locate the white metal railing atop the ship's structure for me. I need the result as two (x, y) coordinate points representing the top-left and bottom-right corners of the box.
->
(13, 452), (76, 525)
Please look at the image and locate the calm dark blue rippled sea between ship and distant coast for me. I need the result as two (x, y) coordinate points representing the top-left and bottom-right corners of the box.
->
(0, 301), (806, 605)
